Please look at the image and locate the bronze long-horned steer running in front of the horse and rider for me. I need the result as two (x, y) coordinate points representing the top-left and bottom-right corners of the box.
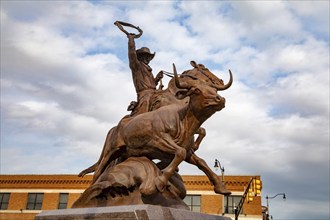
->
(89, 62), (233, 195)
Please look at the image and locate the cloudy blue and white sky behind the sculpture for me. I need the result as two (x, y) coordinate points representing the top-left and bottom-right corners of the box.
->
(0, 0), (330, 219)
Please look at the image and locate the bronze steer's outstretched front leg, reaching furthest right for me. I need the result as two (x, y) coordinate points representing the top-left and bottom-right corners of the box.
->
(186, 150), (231, 195)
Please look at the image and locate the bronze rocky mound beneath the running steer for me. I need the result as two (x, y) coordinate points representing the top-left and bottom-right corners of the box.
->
(72, 157), (189, 210)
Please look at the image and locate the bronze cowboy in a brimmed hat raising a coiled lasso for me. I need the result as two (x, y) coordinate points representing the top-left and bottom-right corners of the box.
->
(115, 21), (163, 116)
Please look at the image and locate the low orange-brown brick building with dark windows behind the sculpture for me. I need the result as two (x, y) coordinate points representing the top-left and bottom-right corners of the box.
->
(0, 175), (262, 220)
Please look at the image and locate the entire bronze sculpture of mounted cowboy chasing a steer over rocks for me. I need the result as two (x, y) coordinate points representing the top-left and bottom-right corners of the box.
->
(73, 22), (233, 209)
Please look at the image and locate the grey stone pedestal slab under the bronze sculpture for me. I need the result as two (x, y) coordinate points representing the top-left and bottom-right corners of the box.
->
(35, 205), (231, 220)
